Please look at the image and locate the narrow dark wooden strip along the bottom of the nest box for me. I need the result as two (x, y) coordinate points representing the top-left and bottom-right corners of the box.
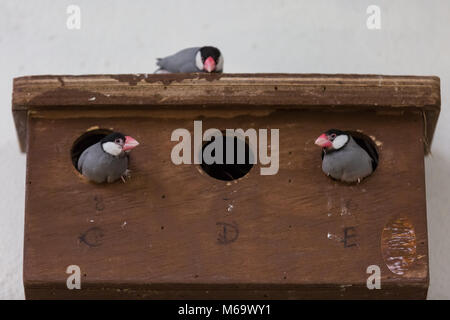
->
(27, 283), (426, 300)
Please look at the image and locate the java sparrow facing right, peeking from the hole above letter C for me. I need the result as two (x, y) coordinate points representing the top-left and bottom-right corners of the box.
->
(78, 132), (139, 183)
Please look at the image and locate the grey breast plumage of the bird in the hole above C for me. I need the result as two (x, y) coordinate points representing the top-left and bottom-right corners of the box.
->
(78, 142), (128, 183)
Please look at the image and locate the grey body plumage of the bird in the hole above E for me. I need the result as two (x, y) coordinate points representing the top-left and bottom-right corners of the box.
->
(322, 136), (373, 182)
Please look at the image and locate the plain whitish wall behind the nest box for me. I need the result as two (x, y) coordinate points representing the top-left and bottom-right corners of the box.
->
(0, 0), (450, 299)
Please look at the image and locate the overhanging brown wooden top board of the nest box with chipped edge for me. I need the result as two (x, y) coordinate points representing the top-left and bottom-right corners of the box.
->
(12, 73), (441, 153)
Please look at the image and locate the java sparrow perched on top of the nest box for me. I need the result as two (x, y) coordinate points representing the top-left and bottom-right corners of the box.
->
(155, 46), (223, 73)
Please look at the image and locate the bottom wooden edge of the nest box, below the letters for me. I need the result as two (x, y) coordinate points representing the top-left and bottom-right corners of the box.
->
(24, 281), (428, 300)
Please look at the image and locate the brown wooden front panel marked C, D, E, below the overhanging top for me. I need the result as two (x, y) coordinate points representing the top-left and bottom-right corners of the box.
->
(24, 107), (428, 299)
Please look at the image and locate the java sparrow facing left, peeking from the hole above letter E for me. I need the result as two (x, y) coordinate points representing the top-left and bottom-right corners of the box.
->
(315, 129), (378, 183)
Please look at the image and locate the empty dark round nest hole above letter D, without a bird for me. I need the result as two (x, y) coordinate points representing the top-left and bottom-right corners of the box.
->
(200, 135), (254, 181)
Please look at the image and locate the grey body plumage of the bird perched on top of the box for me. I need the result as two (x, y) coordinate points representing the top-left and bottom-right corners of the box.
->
(156, 47), (202, 73)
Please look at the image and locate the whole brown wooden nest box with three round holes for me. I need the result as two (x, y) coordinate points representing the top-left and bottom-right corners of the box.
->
(13, 74), (440, 299)
